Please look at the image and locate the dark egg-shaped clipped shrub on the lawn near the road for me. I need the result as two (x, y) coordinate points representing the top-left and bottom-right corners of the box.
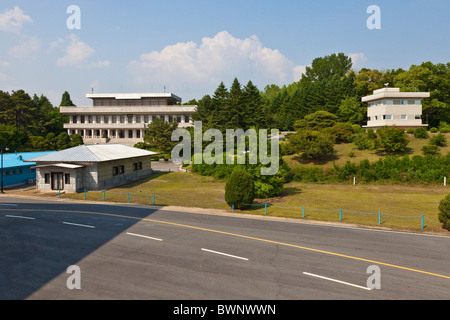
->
(225, 167), (255, 209)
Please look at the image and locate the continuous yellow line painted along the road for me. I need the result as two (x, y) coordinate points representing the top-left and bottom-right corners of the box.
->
(0, 209), (450, 279)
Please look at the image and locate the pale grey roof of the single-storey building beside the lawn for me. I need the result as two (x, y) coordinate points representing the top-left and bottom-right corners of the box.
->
(26, 144), (157, 163)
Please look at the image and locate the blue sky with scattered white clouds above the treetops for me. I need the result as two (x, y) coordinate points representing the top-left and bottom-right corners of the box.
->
(0, 0), (450, 105)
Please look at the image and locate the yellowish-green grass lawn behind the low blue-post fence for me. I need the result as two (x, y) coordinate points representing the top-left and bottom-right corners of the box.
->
(60, 173), (448, 234)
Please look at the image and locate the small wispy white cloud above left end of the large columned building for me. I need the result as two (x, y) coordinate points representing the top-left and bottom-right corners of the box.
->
(56, 34), (110, 68)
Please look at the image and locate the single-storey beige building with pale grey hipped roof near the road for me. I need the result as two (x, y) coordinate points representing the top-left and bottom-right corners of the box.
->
(26, 144), (156, 192)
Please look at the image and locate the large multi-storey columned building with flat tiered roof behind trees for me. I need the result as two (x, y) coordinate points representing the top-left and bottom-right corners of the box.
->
(60, 93), (196, 146)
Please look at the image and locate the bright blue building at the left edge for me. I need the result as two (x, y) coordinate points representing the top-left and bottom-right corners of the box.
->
(0, 151), (55, 188)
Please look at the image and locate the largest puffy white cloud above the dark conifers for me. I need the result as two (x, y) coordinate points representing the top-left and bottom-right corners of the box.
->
(128, 31), (304, 99)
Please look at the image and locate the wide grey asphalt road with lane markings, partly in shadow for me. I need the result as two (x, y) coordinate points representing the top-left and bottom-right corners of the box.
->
(0, 196), (450, 300)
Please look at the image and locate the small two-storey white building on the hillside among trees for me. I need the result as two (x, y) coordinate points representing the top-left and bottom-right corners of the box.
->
(362, 88), (430, 130)
